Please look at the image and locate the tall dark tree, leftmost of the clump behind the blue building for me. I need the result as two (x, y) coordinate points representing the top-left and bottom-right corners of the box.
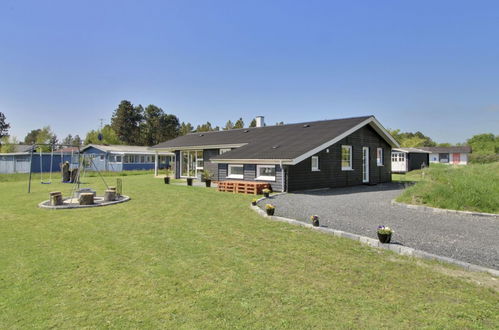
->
(111, 100), (144, 145)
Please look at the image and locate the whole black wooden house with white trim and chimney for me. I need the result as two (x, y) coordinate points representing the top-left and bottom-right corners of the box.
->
(152, 116), (399, 191)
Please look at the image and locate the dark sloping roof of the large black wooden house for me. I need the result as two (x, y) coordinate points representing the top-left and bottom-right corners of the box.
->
(153, 116), (398, 160)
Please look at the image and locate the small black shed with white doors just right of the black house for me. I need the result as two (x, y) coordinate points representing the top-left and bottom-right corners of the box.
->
(392, 148), (430, 173)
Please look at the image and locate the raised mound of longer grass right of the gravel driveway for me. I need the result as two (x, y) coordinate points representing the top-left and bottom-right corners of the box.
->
(394, 163), (499, 213)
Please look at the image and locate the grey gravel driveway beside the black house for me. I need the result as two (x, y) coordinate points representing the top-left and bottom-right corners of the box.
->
(259, 183), (499, 269)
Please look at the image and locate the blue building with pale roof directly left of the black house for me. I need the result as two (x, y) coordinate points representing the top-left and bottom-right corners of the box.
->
(82, 144), (175, 172)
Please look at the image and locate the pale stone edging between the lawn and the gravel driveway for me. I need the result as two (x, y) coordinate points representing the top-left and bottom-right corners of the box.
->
(250, 197), (499, 277)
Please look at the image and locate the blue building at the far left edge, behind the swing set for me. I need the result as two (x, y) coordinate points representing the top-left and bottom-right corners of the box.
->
(0, 145), (78, 174)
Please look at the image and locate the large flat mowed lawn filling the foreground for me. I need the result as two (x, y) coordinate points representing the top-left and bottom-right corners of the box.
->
(0, 175), (499, 329)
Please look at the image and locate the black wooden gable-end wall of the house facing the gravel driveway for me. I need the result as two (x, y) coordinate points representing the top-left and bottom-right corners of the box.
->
(287, 126), (391, 191)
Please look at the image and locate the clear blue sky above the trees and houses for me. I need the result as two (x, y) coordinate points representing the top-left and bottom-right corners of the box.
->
(0, 0), (499, 143)
